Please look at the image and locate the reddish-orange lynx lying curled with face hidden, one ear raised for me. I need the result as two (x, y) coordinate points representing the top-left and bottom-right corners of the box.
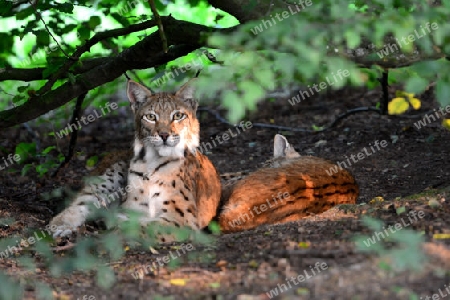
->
(219, 134), (358, 233)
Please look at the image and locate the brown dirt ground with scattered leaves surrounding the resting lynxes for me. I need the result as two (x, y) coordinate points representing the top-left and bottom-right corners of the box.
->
(0, 85), (450, 299)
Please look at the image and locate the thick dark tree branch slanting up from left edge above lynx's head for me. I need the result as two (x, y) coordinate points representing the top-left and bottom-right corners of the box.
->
(0, 16), (234, 128)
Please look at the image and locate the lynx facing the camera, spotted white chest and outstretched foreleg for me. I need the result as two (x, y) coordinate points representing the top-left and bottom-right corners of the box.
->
(50, 80), (221, 236)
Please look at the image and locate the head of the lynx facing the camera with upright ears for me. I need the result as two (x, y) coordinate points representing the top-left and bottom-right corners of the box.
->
(127, 79), (200, 157)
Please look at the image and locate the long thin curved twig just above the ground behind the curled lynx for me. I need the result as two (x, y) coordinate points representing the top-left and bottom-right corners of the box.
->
(198, 106), (381, 133)
